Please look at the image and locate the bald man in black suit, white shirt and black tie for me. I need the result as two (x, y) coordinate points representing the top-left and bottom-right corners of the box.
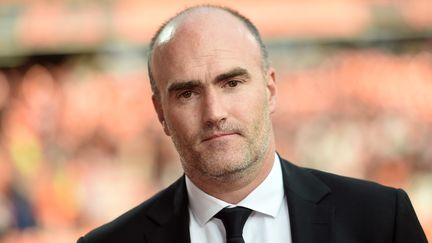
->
(78, 6), (427, 243)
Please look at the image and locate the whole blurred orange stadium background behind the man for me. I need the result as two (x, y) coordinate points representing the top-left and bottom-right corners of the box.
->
(0, 0), (432, 243)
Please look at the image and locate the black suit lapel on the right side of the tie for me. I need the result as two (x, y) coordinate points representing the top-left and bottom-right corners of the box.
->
(281, 159), (334, 243)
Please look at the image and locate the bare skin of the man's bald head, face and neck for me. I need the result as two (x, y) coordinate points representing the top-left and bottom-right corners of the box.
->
(150, 7), (277, 204)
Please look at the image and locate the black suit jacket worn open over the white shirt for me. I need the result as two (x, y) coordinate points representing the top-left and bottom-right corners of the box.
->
(78, 159), (427, 243)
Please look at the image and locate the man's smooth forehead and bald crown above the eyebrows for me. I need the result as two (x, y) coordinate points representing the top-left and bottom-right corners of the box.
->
(151, 10), (261, 88)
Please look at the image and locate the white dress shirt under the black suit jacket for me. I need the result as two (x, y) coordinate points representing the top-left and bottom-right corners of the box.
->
(186, 155), (291, 243)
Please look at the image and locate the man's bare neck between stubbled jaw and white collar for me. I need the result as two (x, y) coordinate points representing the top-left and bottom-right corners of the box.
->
(190, 146), (275, 204)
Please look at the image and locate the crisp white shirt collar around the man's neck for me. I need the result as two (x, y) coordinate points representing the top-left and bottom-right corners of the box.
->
(186, 154), (285, 226)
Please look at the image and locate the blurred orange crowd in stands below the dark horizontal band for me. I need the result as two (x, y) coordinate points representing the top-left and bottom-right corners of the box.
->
(0, 47), (432, 243)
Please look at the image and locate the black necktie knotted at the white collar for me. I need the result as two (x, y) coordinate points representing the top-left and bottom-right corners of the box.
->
(215, 207), (252, 243)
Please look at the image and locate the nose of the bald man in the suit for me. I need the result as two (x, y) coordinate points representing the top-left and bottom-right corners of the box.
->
(202, 89), (227, 127)
